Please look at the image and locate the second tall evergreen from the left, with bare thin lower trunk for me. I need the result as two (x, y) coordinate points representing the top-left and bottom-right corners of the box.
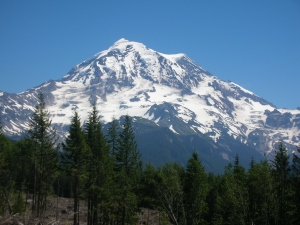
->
(62, 112), (88, 225)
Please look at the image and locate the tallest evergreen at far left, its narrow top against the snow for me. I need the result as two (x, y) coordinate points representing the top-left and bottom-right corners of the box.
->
(27, 92), (58, 216)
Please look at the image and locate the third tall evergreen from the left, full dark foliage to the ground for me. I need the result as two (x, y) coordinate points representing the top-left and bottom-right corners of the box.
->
(85, 104), (115, 225)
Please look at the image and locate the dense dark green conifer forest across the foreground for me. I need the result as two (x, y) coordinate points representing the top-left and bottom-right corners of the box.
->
(0, 93), (300, 225)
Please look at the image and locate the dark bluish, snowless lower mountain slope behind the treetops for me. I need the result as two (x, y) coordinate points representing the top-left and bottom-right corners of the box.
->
(104, 116), (263, 174)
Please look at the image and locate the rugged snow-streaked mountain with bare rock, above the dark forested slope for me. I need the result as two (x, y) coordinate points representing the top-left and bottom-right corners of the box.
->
(0, 39), (300, 159)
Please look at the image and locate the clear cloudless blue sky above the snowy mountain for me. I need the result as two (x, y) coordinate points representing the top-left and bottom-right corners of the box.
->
(0, 0), (300, 109)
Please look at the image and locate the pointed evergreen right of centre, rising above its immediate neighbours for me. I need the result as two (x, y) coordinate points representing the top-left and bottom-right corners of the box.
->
(183, 152), (208, 225)
